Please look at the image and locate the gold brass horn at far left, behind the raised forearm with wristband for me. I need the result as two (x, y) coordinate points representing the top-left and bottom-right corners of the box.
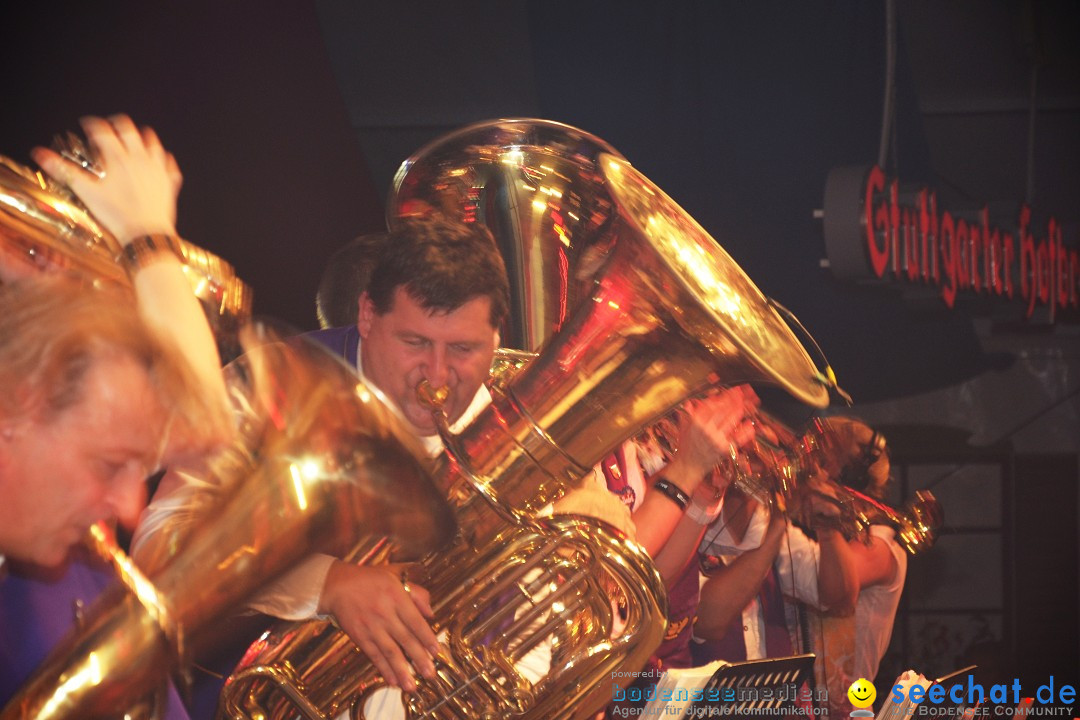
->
(0, 155), (253, 336)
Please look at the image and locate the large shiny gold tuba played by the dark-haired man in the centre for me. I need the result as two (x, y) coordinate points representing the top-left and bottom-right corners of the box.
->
(219, 121), (827, 720)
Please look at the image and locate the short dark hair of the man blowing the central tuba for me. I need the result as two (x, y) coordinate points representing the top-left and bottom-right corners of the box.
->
(367, 217), (510, 328)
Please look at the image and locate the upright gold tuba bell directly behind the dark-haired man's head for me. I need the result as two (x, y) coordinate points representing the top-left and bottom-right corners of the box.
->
(387, 119), (622, 351)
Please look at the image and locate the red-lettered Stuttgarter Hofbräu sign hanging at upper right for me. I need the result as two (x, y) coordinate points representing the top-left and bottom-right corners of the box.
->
(825, 166), (1080, 322)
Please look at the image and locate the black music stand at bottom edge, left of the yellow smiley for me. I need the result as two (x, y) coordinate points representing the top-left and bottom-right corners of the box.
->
(683, 653), (818, 720)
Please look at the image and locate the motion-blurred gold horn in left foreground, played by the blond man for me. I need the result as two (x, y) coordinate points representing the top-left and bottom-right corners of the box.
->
(0, 328), (455, 720)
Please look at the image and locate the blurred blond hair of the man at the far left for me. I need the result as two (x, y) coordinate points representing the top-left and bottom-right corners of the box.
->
(0, 275), (200, 440)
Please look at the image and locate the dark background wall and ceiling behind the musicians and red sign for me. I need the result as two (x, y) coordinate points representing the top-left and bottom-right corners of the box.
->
(0, 0), (1080, 699)
